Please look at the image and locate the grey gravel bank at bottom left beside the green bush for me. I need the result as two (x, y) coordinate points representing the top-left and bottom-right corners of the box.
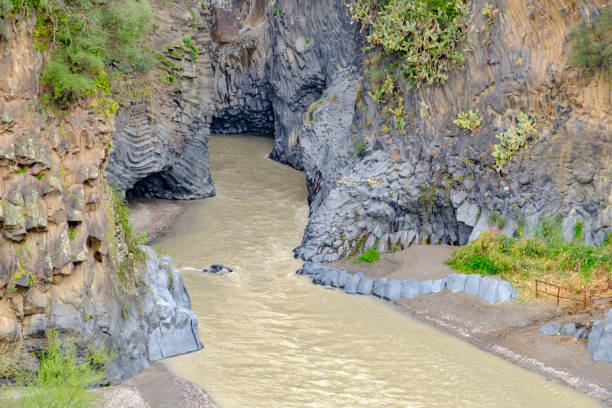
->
(104, 363), (217, 408)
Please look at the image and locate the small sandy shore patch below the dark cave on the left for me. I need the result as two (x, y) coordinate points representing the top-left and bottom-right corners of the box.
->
(128, 198), (183, 242)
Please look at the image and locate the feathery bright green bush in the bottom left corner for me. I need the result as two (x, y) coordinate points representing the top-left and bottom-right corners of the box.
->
(0, 332), (114, 408)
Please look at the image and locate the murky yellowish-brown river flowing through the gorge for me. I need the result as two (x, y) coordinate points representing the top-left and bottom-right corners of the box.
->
(154, 136), (599, 408)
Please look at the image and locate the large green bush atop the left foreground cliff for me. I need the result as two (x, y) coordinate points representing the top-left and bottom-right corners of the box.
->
(8, 0), (154, 106)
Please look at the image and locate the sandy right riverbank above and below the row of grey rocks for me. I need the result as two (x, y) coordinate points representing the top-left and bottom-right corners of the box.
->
(337, 245), (612, 406)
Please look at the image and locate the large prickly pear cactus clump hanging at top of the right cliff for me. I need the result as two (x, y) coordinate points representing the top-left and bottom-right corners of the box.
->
(348, 0), (470, 134)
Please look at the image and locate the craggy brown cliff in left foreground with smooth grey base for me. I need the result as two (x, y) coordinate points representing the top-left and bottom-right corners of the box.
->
(0, 20), (201, 381)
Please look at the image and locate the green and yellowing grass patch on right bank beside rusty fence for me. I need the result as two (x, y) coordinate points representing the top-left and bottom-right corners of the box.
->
(446, 217), (612, 299)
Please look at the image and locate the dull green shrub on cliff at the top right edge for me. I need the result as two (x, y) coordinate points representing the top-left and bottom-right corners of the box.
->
(568, 3), (612, 78)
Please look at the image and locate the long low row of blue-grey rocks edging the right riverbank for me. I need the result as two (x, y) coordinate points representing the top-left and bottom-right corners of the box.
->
(296, 262), (517, 303)
